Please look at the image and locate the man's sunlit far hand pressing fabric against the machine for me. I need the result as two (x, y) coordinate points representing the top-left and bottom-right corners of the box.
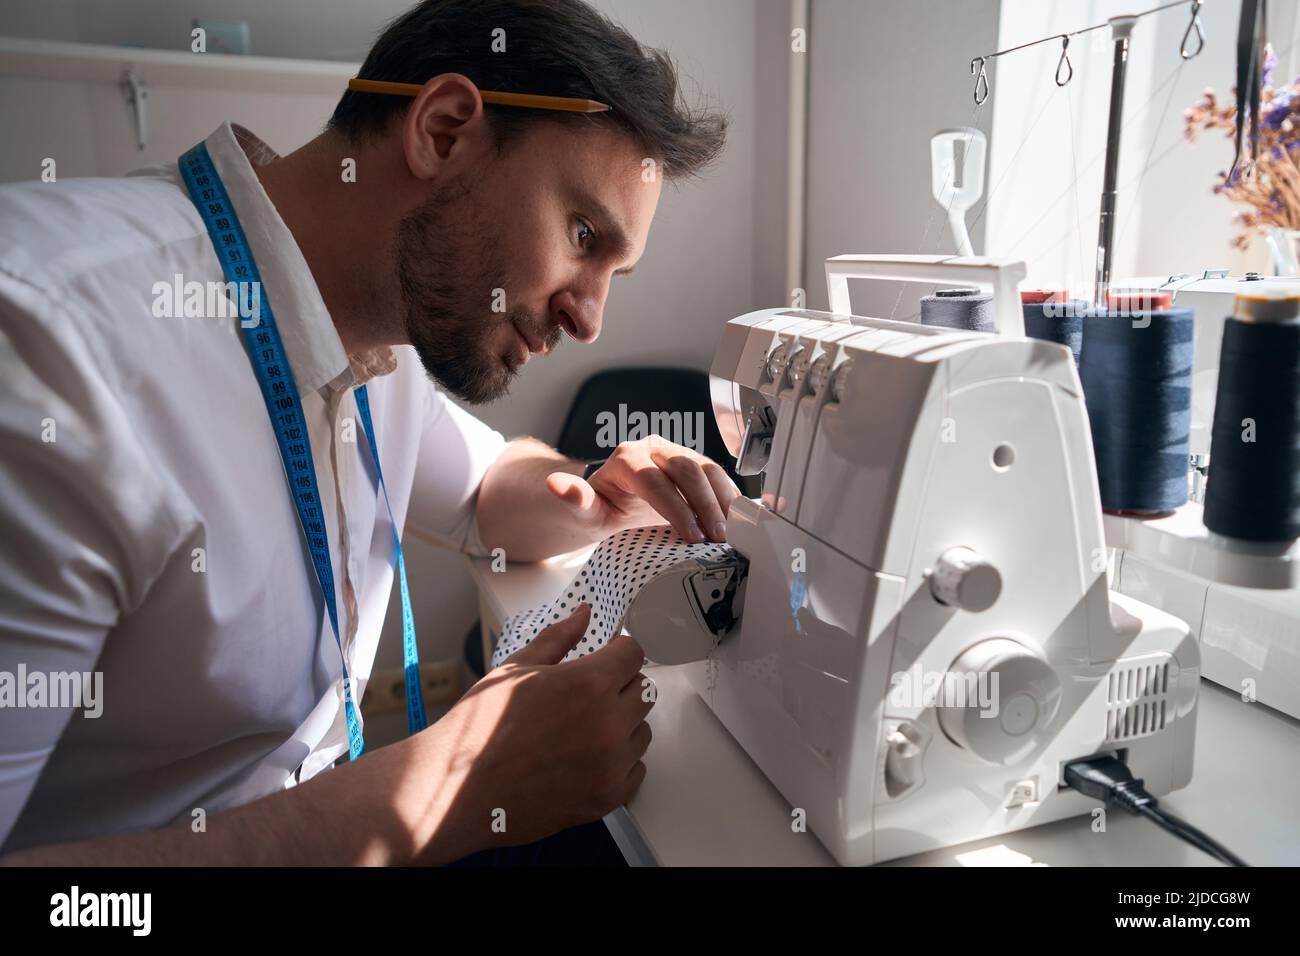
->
(546, 434), (740, 542)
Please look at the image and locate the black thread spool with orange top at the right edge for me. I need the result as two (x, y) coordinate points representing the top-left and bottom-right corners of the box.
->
(1205, 295), (1300, 542)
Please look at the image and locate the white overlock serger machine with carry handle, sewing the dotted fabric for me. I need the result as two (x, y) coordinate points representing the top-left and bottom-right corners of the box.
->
(625, 256), (1200, 864)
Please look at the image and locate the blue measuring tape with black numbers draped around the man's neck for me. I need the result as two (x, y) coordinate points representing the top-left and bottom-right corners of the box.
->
(179, 143), (425, 760)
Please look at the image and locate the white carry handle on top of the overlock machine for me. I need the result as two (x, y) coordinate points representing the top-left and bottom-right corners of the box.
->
(826, 255), (1024, 338)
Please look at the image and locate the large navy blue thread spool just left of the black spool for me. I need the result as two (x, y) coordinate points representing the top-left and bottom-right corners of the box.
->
(1079, 303), (1192, 516)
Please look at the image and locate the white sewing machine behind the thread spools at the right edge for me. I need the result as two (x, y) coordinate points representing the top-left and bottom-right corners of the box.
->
(1105, 271), (1300, 718)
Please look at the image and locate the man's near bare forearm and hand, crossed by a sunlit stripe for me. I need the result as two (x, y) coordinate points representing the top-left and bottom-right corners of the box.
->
(0, 607), (654, 866)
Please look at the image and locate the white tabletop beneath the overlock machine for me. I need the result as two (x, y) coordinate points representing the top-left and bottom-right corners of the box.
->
(468, 551), (1300, 866)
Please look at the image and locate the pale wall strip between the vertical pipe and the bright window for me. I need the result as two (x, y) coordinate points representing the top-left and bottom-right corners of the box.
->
(800, 0), (998, 319)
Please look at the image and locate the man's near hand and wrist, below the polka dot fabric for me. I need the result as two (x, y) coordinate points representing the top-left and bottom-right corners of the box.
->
(400, 605), (654, 862)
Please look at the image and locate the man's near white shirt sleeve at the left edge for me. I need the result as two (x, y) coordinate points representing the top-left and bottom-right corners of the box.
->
(0, 274), (176, 847)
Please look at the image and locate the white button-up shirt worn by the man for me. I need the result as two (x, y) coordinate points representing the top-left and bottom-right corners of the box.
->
(0, 124), (506, 849)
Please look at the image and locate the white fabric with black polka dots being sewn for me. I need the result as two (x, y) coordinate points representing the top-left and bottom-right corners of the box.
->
(491, 527), (731, 667)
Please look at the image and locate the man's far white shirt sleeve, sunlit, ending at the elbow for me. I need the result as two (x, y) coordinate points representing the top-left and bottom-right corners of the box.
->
(407, 382), (507, 555)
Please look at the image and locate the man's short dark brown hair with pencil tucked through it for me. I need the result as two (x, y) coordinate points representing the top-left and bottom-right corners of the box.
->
(328, 0), (727, 178)
